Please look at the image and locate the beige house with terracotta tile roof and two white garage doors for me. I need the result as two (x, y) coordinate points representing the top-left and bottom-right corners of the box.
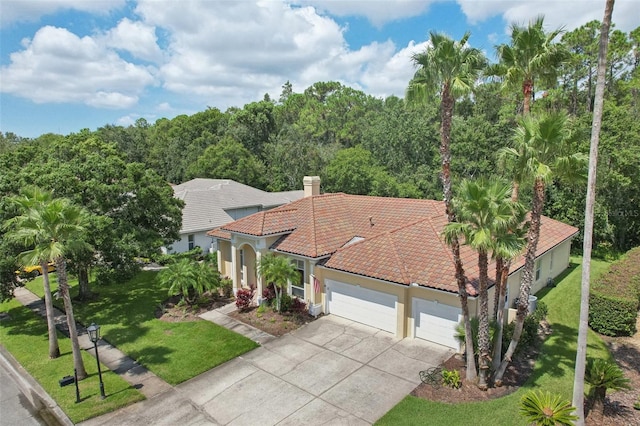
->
(209, 178), (578, 349)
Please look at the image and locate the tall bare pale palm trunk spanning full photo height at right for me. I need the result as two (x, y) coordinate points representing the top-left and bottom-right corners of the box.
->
(572, 0), (614, 425)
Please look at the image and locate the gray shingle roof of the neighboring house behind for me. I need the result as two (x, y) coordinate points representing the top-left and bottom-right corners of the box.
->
(173, 178), (304, 234)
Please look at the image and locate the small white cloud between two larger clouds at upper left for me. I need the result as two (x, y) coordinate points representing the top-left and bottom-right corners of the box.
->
(105, 18), (162, 63)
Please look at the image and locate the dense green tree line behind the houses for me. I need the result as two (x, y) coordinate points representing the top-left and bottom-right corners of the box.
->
(0, 21), (640, 268)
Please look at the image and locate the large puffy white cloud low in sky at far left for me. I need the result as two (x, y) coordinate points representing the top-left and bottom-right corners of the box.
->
(0, 26), (154, 108)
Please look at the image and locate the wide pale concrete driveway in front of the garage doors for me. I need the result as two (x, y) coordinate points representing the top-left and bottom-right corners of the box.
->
(80, 315), (453, 425)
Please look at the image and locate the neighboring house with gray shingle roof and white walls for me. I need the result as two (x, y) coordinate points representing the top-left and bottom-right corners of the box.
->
(166, 179), (303, 253)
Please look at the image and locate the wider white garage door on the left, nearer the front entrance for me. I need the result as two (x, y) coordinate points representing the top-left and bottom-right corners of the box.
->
(325, 280), (398, 334)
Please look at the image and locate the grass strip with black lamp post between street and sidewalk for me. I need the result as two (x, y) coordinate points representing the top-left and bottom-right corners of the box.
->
(0, 300), (144, 423)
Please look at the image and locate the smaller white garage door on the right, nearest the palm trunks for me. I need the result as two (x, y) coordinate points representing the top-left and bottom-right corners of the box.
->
(413, 298), (462, 350)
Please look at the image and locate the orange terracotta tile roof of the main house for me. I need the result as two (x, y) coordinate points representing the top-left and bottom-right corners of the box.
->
(210, 194), (578, 295)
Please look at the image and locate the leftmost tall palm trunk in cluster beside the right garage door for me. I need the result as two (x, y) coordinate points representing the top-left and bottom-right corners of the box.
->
(440, 88), (477, 381)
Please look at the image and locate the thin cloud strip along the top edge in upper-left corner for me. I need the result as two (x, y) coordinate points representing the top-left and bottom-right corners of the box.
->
(0, 0), (126, 27)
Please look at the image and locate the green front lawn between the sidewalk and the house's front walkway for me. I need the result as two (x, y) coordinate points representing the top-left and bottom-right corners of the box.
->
(27, 271), (258, 385)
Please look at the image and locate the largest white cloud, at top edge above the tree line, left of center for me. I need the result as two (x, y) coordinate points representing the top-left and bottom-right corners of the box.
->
(136, 1), (346, 107)
